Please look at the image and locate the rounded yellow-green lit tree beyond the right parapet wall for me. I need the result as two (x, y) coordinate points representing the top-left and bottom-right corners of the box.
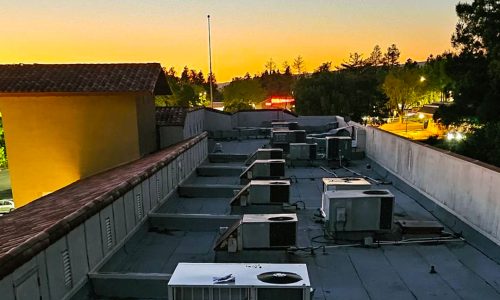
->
(382, 63), (426, 122)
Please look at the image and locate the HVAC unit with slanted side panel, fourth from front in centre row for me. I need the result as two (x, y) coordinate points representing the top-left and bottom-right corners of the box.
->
(240, 159), (285, 183)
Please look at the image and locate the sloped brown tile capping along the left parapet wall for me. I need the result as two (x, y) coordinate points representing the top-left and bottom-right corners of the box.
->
(0, 133), (207, 280)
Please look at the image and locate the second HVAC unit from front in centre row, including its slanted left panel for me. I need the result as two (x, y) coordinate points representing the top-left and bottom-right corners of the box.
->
(214, 214), (297, 252)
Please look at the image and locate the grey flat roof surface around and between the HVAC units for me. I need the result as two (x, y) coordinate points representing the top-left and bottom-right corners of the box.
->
(90, 139), (500, 300)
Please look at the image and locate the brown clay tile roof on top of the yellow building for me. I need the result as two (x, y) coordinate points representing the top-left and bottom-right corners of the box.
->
(0, 63), (170, 95)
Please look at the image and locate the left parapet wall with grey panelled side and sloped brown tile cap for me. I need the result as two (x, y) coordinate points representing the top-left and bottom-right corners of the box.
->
(0, 133), (208, 300)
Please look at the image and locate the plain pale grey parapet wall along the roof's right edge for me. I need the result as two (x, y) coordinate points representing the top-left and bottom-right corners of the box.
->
(360, 126), (500, 245)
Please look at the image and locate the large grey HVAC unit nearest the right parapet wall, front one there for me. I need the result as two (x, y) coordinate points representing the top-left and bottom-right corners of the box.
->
(323, 190), (394, 232)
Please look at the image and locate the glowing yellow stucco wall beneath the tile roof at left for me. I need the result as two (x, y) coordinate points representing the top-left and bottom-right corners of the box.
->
(0, 95), (140, 207)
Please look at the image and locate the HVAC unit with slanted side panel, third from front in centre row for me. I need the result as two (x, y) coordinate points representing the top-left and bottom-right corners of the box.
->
(231, 180), (290, 206)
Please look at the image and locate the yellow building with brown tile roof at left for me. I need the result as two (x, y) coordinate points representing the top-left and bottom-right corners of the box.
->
(0, 63), (170, 206)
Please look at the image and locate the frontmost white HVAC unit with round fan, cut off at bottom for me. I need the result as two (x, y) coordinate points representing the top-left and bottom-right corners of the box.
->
(168, 263), (311, 300)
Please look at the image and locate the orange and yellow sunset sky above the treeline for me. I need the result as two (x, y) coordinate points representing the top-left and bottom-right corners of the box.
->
(0, 0), (464, 82)
